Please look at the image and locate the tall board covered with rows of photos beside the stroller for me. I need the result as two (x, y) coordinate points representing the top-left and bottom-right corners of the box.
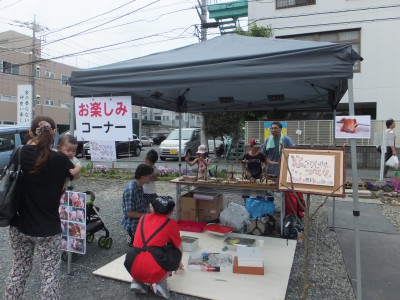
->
(58, 191), (86, 254)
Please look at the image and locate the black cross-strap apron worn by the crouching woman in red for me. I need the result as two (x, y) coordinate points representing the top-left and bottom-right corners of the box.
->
(124, 217), (182, 273)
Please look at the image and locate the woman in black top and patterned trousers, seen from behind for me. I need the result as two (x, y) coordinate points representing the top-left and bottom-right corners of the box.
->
(5, 116), (74, 300)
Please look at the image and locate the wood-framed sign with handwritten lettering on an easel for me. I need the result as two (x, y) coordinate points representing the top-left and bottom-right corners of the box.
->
(278, 148), (345, 197)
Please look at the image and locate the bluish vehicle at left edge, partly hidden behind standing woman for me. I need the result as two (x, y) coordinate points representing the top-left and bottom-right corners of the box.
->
(0, 125), (30, 170)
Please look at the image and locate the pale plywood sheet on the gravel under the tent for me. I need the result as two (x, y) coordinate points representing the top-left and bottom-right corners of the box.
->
(93, 231), (296, 300)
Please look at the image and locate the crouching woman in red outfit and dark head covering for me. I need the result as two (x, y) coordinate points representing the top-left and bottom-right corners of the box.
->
(130, 197), (183, 298)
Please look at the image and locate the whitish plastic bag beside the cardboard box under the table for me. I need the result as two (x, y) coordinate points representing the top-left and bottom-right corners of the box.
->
(219, 202), (250, 232)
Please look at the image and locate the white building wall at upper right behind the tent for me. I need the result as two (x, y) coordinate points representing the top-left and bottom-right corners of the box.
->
(248, 0), (400, 120)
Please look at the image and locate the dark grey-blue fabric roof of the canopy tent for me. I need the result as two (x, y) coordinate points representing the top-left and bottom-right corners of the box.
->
(70, 35), (362, 112)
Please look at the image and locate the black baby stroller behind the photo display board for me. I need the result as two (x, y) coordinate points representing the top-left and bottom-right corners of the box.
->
(84, 191), (113, 249)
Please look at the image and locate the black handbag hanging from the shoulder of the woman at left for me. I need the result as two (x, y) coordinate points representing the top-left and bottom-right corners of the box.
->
(0, 146), (22, 227)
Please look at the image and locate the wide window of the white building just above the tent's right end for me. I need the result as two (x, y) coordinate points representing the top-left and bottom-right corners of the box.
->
(279, 29), (361, 72)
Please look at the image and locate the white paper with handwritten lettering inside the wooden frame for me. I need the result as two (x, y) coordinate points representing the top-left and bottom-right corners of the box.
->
(286, 153), (335, 186)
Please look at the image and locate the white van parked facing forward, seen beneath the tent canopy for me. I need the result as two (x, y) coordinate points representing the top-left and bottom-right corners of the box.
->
(159, 128), (222, 160)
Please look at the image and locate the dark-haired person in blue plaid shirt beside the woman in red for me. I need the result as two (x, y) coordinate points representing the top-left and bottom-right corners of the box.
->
(121, 164), (154, 247)
